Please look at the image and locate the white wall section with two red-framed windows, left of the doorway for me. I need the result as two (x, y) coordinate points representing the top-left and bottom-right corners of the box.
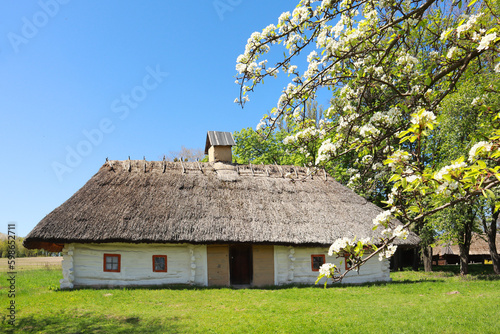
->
(67, 243), (207, 286)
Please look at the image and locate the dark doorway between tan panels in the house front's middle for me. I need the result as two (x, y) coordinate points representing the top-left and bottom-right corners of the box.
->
(229, 245), (253, 285)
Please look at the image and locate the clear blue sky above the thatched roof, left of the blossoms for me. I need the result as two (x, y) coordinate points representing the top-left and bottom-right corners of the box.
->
(0, 0), (332, 236)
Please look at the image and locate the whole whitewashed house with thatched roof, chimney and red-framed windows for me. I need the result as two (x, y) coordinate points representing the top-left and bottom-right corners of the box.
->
(24, 131), (418, 288)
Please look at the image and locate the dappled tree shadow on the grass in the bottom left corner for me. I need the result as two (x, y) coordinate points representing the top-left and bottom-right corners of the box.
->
(0, 313), (180, 334)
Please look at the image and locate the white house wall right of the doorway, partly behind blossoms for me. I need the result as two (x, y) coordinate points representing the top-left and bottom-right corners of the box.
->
(274, 246), (391, 285)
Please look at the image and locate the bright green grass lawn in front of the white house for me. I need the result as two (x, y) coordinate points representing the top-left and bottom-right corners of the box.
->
(0, 265), (500, 333)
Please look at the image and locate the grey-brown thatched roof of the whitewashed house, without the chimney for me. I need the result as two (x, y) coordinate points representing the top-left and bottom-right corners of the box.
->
(24, 160), (419, 250)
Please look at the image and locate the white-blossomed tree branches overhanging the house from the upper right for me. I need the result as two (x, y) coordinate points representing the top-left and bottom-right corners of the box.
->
(235, 0), (500, 281)
